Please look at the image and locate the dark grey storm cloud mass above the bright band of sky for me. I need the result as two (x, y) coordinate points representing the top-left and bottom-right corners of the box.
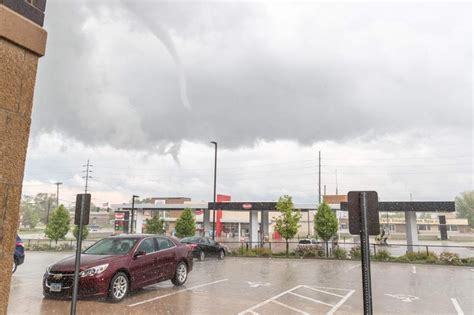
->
(33, 0), (472, 151)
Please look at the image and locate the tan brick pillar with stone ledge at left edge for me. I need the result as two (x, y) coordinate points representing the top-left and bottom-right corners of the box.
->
(0, 0), (47, 314)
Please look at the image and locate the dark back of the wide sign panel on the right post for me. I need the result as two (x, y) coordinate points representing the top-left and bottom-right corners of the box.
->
(347, 191), (380, 235)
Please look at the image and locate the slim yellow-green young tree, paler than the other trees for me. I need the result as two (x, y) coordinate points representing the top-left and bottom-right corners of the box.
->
(275, 195), (301, 256)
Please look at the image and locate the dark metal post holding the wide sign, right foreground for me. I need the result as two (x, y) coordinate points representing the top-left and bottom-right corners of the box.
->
(360, 192), (373, 315)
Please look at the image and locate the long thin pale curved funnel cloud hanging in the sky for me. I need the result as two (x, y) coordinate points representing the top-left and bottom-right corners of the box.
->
(123, 1), (191, 109)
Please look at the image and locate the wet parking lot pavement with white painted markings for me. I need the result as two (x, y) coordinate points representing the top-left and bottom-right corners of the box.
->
(8, 252), (474, 315)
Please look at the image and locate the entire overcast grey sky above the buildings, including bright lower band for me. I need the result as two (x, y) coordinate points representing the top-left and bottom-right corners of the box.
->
(24, 0), (473, 204)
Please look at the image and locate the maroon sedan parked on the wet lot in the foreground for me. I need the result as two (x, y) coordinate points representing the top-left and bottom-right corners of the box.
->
(43, 235), (193, 302)
